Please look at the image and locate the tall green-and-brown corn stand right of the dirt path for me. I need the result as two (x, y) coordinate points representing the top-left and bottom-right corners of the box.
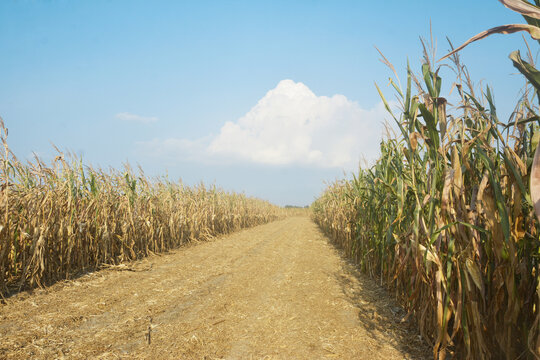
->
(312, 48), (540, 359)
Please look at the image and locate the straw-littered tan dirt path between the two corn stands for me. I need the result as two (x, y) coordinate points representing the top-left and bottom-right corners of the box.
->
(0, 217), (429, 359)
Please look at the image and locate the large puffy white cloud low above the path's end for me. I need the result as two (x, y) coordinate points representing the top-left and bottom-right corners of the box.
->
(139, 80), (387, 170)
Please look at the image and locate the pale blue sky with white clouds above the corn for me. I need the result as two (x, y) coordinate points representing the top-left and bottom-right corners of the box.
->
(0, 0), (536, 205)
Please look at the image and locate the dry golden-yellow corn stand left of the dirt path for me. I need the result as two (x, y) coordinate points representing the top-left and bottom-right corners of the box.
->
(0, 119), (284, 296)
